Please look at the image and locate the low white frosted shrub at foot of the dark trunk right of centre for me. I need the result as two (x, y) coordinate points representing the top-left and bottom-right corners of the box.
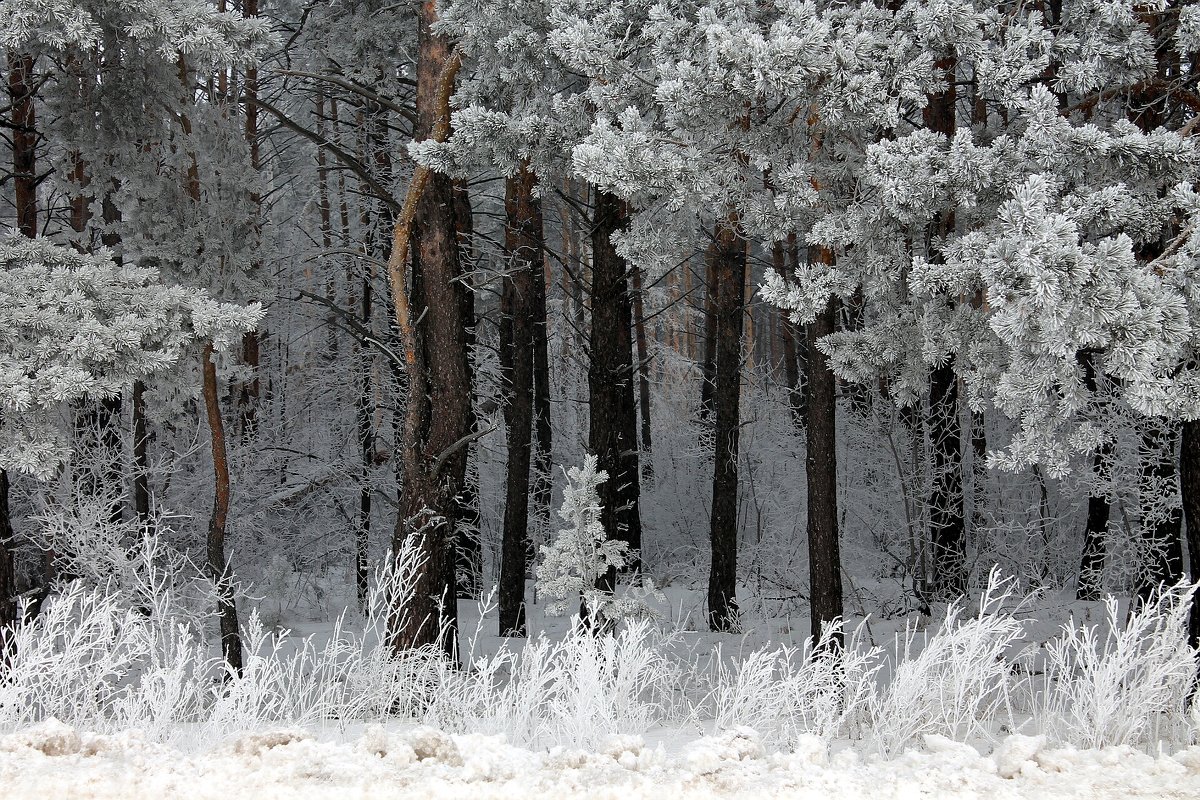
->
(692, 620), (881, 748)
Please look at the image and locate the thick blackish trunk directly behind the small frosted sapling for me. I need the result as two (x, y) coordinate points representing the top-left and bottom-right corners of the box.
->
(588, 190), (642, 575)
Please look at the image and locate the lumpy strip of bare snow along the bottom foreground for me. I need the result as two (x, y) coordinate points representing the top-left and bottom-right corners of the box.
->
(0, 720), (1200, 800)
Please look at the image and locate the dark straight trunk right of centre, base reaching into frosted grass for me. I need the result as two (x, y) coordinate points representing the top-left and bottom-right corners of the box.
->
(804, 275), (842, 642)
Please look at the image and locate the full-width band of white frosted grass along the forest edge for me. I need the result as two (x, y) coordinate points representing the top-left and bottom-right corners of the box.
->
(0, 537), (1200, 758)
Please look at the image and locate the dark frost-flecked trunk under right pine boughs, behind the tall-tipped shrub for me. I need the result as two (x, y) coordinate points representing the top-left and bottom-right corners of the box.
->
(929, 362), (967, 600)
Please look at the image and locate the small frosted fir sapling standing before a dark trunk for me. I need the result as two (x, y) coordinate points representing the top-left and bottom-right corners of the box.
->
(536, 456), (662, 628)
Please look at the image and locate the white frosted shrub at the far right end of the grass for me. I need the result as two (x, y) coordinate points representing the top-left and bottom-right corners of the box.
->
(1036, 584), (1196, 747)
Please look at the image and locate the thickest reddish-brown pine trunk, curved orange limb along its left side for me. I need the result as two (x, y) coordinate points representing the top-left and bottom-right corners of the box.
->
(388, 0), (472, 662)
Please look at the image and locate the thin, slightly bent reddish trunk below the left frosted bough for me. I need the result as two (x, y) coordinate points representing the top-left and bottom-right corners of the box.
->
(200, 344), (242, 675)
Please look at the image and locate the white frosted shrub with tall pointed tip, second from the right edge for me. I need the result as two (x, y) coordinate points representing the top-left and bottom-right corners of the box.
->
(871, 570), (1024, 754)
